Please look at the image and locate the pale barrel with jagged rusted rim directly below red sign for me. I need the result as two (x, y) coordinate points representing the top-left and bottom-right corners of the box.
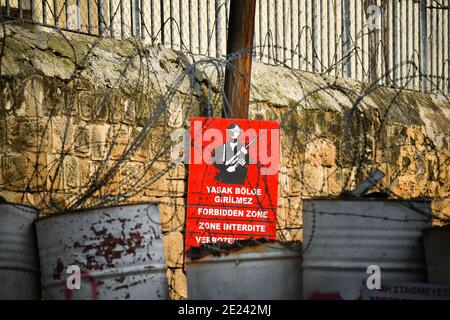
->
(186, 243), (302, 300)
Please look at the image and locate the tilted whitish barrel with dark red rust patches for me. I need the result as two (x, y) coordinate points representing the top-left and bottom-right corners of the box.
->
(36, 204), (168, 300)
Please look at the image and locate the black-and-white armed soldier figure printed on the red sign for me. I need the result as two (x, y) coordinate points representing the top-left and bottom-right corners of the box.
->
(213, 123), (250, 184)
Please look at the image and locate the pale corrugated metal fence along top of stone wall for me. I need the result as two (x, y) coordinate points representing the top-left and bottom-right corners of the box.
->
(0, 0), (450, 93)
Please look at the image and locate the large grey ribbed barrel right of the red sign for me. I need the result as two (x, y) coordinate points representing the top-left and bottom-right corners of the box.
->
(303, 198), (432, 300)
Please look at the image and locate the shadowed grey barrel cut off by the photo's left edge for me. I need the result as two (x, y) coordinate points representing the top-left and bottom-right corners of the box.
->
(0, 203), (41, 300)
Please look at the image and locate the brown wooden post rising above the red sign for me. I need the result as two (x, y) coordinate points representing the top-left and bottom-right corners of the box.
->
(222, 0), (256, 119)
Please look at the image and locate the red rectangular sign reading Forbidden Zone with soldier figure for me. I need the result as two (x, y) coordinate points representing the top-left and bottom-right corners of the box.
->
(186, 118), (280, 250)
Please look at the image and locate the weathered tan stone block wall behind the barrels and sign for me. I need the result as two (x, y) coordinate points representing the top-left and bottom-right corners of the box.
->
(0, 26), (450, 299)
